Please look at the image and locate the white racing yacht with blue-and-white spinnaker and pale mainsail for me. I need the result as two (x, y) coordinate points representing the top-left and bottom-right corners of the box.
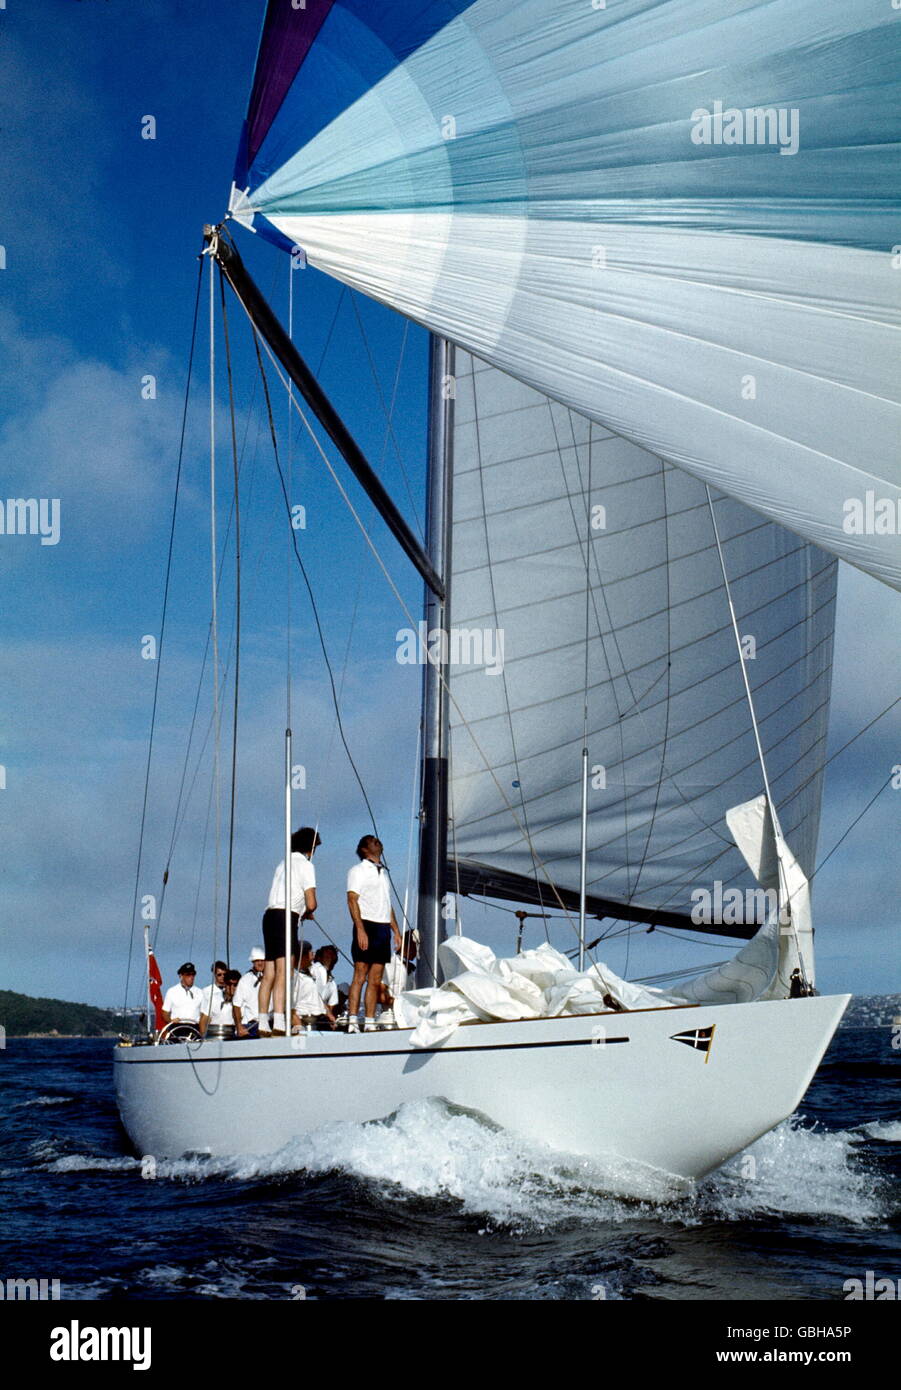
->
(115, 0), (901, 1179)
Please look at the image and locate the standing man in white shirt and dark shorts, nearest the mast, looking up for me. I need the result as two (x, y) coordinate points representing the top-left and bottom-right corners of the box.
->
(348, 835), (400, 1033)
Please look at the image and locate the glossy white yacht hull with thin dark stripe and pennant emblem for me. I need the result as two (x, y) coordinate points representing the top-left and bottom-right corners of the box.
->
(115, 994), (850, 1177)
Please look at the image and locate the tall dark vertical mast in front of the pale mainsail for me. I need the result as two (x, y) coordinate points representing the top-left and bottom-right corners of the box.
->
(416, 336), (453, 987)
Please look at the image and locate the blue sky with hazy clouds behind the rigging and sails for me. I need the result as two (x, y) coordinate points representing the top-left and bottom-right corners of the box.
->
(0, 0), (901, 1022)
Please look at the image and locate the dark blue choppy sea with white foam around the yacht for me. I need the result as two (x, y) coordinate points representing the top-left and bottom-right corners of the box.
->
(0, 1029), (901, 1301)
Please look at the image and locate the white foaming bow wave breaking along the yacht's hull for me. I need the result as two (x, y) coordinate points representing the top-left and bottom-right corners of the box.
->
(33, 1099), (901, 1230)
